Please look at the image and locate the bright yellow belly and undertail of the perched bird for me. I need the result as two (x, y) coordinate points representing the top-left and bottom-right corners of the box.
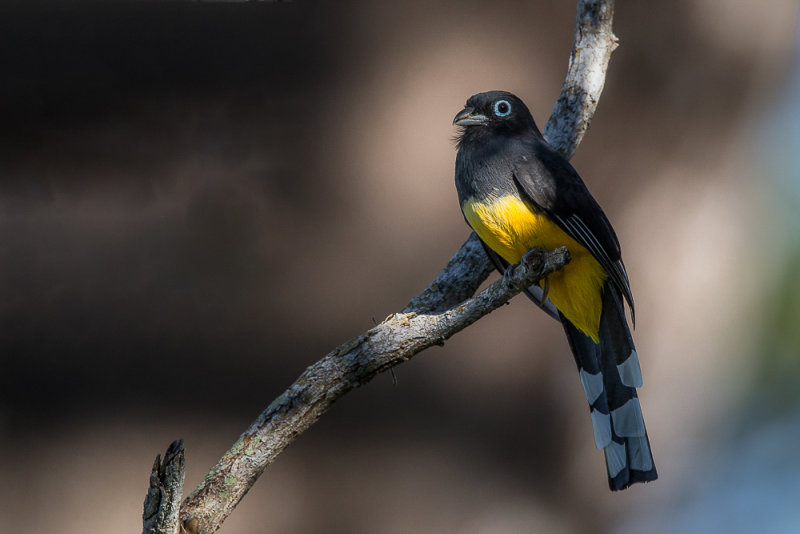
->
(461, 195), (608, 343)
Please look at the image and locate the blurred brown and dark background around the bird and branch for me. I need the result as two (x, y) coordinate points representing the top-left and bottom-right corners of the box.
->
(0, 0), (800, 534)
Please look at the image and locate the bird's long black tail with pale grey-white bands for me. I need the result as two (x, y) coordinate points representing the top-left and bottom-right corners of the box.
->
(561, 282), (658, 491)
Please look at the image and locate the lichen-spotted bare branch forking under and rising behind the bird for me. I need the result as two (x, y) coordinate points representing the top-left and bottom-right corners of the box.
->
(146, 0), (617, 534)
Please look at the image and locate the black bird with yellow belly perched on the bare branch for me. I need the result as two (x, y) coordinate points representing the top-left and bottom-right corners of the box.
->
(453, 91), (658, 491)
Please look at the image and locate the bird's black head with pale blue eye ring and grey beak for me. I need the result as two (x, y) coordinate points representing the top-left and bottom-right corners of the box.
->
(453, 91), (539, 141)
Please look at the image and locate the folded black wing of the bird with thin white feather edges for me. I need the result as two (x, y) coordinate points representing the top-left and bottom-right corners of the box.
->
(514, 140), (636, 324)
